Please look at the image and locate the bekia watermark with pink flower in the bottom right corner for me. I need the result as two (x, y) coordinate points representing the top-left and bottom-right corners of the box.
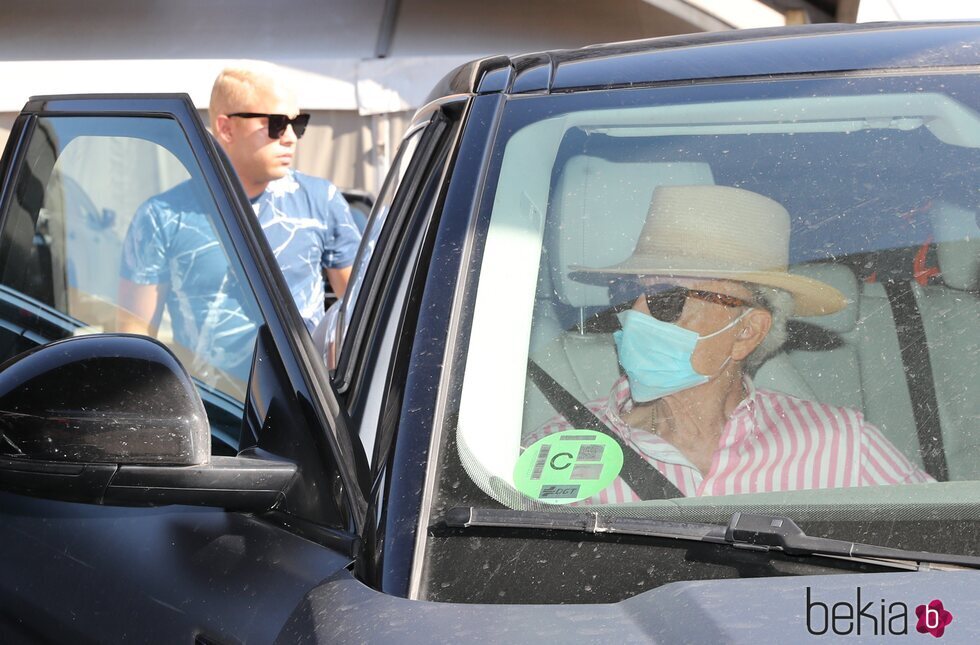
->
(806, 587), (953, 638)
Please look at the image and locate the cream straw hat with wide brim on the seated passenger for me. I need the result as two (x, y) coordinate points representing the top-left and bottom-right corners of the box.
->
(570, 185), (847, 316)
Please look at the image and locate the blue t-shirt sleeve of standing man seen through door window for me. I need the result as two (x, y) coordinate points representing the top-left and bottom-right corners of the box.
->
(120, 199), (170, 284)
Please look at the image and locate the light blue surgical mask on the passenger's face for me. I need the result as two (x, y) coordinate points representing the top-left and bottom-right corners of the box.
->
(613, 309), (752, 402)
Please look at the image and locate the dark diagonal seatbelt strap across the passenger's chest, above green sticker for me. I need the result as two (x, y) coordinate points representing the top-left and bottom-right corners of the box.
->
(527, 358), (684, 500)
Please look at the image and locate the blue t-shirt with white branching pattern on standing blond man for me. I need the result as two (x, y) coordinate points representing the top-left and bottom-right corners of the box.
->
(121, 172), (360, 380)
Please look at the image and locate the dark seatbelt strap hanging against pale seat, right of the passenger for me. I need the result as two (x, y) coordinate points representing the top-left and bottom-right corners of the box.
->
(882, 280), (949, 481)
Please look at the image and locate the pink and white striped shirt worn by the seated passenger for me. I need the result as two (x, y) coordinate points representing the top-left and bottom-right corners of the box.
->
(526, 377), (934, 504)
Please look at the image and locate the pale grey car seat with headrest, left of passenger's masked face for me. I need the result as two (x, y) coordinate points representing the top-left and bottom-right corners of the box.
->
(524, 155), (714, 429)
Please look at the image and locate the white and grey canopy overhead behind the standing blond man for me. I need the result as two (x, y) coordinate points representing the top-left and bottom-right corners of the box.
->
(0, 0), (780, 115)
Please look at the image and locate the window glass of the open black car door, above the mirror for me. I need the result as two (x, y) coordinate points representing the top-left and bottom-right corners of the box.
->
(0, 116), (259, 449)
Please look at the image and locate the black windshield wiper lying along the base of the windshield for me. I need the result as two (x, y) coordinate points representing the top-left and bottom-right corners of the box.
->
(445, 507), (980, 571)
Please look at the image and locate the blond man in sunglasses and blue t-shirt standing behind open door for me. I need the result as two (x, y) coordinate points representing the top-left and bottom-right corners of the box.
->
(120, 64), (360, 379)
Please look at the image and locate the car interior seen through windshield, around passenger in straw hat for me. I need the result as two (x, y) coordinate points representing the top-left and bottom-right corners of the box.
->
(457, 87), (980, 507)
